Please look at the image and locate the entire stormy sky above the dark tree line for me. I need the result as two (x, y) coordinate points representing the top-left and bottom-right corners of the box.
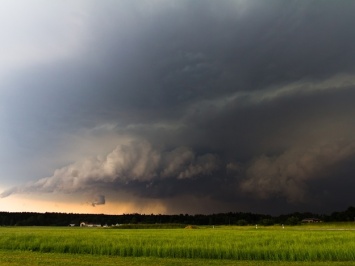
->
(0, 0), (355, 214)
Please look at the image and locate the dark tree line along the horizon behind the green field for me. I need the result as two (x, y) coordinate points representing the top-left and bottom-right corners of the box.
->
(0, 206), (355, 226)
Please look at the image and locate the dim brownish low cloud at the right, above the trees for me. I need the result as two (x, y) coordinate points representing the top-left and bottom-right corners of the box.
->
(240, 141), (355, 202)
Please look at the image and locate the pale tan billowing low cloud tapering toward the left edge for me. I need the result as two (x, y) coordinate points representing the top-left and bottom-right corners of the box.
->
(0, 139), (219, 198)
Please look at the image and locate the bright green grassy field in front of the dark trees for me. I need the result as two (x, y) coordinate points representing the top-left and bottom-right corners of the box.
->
(0, 223), (355, 266)
